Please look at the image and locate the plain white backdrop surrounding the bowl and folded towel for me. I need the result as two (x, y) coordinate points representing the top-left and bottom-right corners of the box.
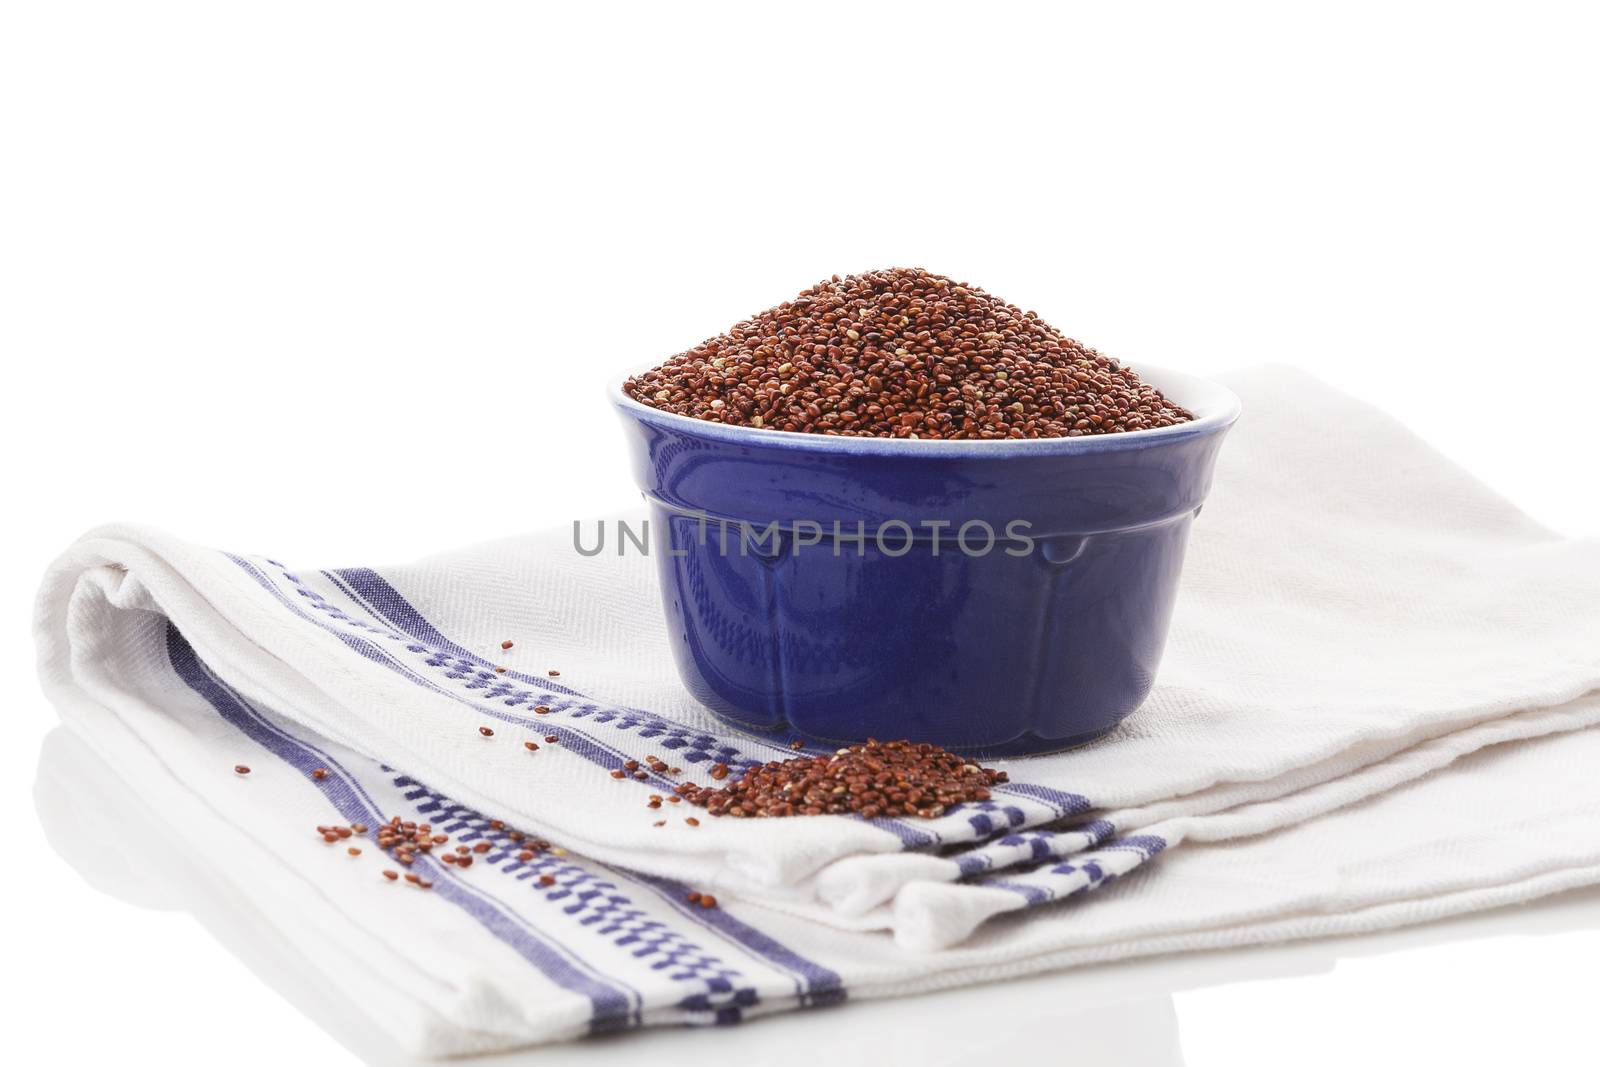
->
(0, 0), (1600, 1067)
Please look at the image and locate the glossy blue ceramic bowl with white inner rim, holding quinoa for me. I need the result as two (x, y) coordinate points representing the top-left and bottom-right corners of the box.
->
(613, 370), (1238, 755)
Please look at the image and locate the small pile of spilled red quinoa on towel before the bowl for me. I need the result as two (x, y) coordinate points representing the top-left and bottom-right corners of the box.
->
(674, 741), (1006, 819)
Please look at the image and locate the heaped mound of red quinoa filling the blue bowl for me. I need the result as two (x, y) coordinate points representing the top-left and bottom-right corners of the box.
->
(622, 267), (1194, 440)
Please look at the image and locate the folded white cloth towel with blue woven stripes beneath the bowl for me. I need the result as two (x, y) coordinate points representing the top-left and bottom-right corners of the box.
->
(38, 371), (1600, 1053)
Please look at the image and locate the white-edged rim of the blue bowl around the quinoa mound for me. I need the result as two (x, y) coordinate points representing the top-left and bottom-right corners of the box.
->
(608, 362), (1242, 459)
